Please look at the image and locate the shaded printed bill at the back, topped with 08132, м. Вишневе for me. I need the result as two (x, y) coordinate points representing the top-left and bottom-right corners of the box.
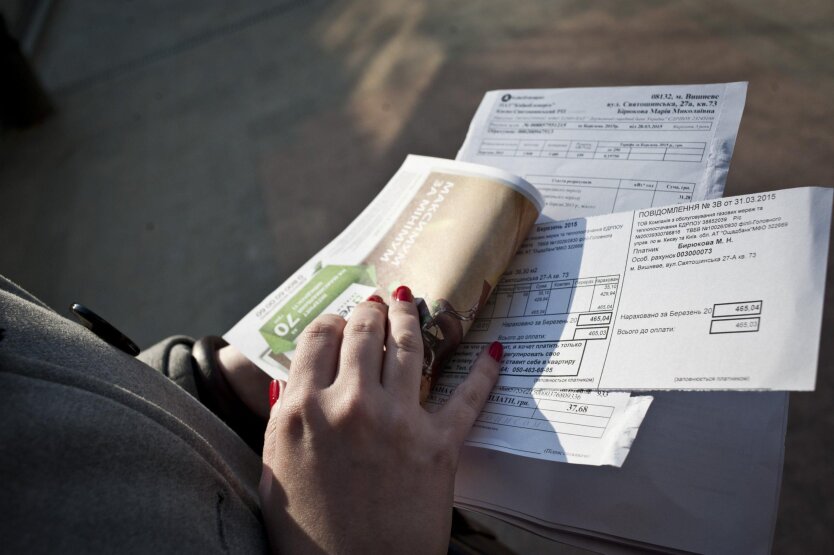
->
(457, 83), (747, 220)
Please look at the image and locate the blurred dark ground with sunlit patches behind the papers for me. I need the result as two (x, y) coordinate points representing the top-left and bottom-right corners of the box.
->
(0, 0), (834, 553)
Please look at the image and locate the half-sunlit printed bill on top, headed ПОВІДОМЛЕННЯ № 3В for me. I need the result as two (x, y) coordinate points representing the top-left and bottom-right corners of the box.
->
(452, 187), (832, 391)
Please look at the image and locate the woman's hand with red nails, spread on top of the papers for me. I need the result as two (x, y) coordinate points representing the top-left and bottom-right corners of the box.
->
(260, 287), (502, 553)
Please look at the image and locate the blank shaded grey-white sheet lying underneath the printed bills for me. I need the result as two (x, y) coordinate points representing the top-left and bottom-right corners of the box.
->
(455, 392), (788, 554)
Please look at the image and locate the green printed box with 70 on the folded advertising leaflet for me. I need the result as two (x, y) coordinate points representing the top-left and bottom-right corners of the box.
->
(260, 266), (376, 354)
